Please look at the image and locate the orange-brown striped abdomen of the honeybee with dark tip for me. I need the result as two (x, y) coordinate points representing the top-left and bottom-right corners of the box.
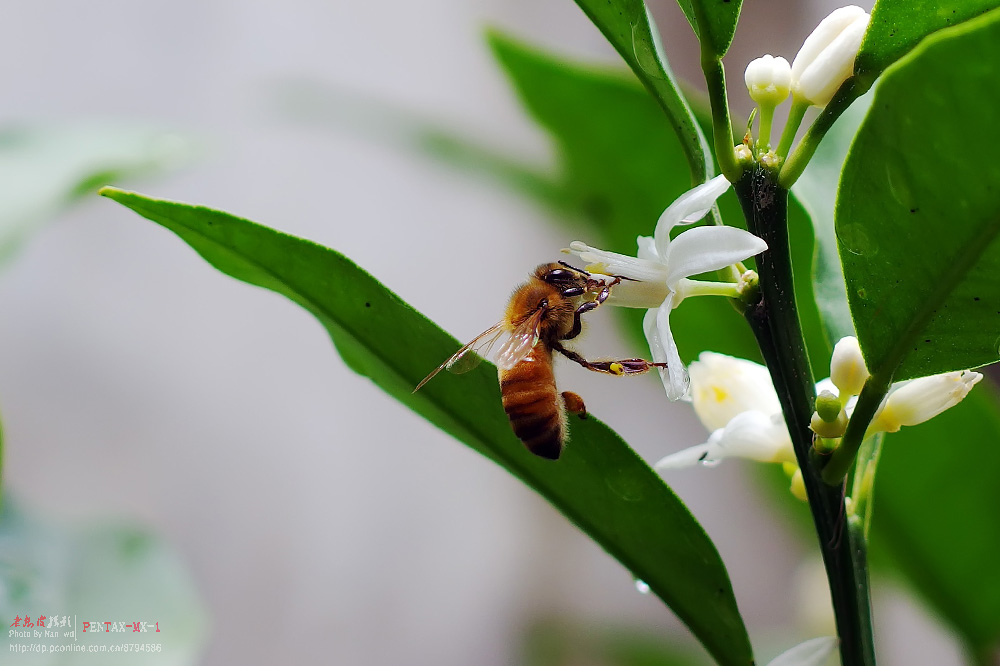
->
(500, 343), (566, 460)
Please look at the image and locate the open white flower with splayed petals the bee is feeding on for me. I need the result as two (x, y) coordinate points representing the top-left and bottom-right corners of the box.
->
(570, 176), (767, 400)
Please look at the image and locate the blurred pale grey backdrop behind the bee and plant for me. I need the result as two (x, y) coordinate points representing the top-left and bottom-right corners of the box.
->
(0, 0), (960, 666)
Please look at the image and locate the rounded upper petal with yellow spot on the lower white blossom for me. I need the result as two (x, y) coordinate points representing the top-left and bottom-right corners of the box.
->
(688, 352), (781, 431)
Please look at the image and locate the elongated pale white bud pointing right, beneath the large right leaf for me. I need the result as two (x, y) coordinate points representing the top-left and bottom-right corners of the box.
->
(869, 370), (983, 432)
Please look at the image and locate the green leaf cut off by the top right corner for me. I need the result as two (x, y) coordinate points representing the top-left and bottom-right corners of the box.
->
(854, 0), (1000, 88)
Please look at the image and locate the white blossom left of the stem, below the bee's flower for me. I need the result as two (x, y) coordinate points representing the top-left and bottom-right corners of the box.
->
(656, 352), (795, 470)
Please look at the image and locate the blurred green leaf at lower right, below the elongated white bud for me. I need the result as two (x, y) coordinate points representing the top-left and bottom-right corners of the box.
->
(872, 382), (1000, 652)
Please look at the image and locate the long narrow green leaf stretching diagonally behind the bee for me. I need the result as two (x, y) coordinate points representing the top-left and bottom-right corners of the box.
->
(101, 188), (751, 666)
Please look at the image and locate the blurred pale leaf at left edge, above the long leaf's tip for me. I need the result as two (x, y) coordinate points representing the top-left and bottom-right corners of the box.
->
(0, 124), (192, 262)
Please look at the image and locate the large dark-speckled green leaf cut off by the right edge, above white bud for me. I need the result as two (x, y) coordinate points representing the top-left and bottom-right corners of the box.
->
(836, 12), (1000, 381)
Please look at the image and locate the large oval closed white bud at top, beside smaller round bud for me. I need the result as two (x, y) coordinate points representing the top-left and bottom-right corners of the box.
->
(792, 5), (871, 107)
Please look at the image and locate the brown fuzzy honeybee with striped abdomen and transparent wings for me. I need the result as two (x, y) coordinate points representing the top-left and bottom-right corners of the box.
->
(413, 262), (666, 460)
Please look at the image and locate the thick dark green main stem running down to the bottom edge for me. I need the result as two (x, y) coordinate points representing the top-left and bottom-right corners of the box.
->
(735, 168), (875, 666)
